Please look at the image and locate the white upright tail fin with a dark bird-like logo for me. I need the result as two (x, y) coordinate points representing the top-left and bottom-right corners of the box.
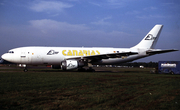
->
(132, 25), (163, 49)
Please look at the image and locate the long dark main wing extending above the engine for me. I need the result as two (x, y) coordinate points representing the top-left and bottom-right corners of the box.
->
(66, 52), (138, 61)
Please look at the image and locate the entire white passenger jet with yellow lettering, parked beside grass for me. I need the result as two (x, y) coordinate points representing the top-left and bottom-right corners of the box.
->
(2, 25), (178, 71)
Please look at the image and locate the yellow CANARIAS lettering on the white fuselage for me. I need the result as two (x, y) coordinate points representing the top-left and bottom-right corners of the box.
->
(62, 50), (100, 56)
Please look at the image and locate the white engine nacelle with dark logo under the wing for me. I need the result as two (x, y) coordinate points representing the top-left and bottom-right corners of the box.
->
(61, 60), (84, 70)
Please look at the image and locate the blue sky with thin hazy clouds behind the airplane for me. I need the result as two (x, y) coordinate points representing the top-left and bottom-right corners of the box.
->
(0, 0), (180, 62)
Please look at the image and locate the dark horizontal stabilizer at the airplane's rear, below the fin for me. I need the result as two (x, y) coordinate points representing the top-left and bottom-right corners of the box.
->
(146, 49), (179, 55)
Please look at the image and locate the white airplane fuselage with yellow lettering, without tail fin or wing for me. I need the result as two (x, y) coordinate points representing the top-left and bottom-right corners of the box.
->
(2, 47), (148, 65)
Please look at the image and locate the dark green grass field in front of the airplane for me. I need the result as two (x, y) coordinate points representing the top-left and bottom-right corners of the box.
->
(0, 67), (180, 110)
